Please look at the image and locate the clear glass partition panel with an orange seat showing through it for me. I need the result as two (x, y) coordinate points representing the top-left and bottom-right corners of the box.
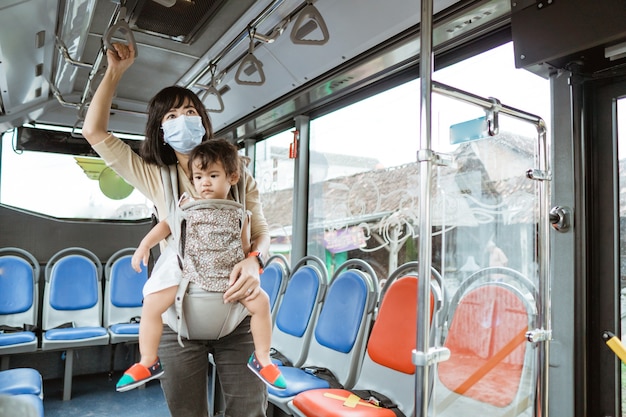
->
(431, 96), (547, 416)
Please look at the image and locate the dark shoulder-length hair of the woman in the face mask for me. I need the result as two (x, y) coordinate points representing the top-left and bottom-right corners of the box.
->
(140, 85), (213, 166)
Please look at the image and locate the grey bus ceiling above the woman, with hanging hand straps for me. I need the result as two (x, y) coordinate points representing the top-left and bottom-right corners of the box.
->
(0, 0), (626, 153)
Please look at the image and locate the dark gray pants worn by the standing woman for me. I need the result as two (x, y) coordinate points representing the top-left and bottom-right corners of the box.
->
(159, 317), (267, 417)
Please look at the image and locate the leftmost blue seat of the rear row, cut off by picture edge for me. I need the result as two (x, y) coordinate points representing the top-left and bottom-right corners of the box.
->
(0, 248), (40, 369)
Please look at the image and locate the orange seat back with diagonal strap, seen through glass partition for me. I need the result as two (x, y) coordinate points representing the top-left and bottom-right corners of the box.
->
(438, 285), (529, 411)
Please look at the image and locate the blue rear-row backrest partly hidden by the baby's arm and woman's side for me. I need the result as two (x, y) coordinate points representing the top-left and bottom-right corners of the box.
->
(103, 248), (148, 327)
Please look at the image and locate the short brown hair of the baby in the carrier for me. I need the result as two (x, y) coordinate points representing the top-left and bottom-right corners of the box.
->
(188, 138), (241, 181)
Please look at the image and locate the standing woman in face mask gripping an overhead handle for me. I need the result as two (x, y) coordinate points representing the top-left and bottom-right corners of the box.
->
(83, 43), (270, 417)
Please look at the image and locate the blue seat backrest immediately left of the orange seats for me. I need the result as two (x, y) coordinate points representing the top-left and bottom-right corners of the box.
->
(302, 259), (378, 388)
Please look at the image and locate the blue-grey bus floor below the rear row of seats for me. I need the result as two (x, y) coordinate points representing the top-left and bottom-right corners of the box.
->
(43, 374), (170, 417)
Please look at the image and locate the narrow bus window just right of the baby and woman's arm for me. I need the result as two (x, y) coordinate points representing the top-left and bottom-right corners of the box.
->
(255, 130), (295, 259)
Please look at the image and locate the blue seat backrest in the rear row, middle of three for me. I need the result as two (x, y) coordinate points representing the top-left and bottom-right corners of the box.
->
(42, 247), (102, 330)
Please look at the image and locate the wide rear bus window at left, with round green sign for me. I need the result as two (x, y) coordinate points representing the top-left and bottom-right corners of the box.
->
(0, 131), (153, 220)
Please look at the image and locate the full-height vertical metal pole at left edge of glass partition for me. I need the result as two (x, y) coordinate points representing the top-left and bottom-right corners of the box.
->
(414, 0), (433, 417)
